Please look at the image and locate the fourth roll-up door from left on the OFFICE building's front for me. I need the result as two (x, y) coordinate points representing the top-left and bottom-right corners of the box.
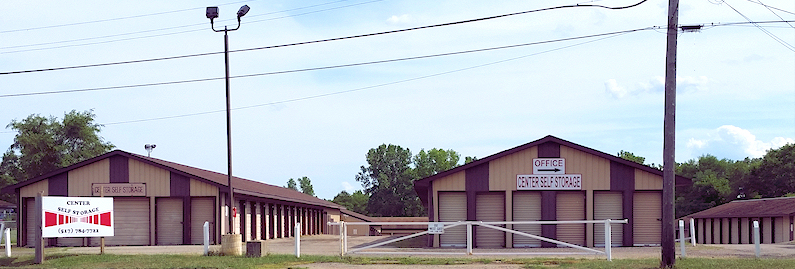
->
(555, 191), (585, 246)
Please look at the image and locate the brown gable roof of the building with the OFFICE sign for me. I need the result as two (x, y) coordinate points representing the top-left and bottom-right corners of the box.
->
(414, 135), (692, 203)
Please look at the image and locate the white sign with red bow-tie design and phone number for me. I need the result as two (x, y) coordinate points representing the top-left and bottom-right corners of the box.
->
(41, 196), (114, 237)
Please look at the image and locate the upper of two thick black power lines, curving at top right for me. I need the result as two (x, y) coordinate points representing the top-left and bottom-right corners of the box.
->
(0, 0), (648, 75)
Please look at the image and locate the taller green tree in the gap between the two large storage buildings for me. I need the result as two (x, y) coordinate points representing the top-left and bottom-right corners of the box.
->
(356, 144), (425, 217)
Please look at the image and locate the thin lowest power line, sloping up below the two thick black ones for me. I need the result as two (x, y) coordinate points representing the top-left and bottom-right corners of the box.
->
(102, 27), (636, 125)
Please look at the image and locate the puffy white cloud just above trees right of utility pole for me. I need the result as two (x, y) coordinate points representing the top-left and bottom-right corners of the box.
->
(687, 125), (795, 160)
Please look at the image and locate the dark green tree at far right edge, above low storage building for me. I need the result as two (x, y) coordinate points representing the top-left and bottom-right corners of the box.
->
(741, 144), (795, 197)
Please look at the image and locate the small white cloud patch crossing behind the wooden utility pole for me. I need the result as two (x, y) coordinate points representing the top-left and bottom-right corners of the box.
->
(605, 76), (710, 99)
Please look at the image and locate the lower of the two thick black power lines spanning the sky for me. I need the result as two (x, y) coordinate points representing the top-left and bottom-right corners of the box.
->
(0, 26), (661, 98)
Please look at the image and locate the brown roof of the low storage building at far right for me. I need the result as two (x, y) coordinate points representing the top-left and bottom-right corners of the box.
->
(685, 197), (795, 218)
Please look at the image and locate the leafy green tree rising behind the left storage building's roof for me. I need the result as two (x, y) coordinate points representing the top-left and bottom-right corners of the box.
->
(0, 110), (114, 199)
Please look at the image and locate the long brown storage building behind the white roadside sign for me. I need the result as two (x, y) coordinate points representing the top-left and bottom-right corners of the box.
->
(3, 150), (344, 246)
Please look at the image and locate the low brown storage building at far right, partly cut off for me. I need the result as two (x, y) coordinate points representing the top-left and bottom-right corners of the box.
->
(684, 197), (795, 244)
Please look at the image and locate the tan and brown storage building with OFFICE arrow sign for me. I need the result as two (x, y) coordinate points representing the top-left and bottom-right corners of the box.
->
(414, 136), (692, 248)
